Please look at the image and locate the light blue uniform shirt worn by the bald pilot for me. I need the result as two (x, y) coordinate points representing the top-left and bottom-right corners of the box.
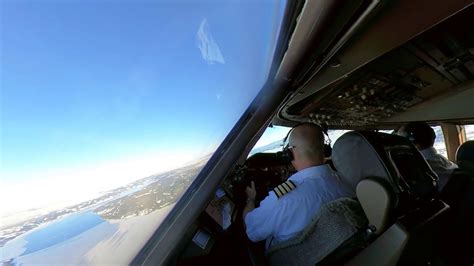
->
(245, 164), (351, 248)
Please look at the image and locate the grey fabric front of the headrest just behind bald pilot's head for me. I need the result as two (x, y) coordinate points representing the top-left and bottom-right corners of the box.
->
(332, 131), (392, 196)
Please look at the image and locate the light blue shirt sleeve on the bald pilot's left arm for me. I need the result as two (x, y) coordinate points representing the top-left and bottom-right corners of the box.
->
(245, 191), (278, 242)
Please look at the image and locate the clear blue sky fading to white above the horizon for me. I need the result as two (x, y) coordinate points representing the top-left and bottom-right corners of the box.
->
(0, 0), (284, 215)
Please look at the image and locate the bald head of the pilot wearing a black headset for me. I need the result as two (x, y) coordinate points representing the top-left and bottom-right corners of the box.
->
(289, 124), (324, 170)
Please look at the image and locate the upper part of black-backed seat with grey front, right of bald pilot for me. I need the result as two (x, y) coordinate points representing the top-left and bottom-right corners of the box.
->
(332, 131), (438, 202)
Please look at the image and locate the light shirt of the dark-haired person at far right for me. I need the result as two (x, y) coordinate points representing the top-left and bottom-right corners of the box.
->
(420, 147), (458, 191)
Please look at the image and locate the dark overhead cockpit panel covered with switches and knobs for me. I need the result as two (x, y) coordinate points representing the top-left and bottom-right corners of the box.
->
(285, 6), (474, 127)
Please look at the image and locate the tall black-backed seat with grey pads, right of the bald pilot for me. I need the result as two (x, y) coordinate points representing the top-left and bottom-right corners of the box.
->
(333, 131), (447, 265)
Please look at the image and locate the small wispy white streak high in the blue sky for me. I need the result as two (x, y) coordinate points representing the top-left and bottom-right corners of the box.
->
(197, 19), (225, 64)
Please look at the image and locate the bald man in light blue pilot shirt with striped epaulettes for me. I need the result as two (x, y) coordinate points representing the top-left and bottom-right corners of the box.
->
(243, 124), (351, 249)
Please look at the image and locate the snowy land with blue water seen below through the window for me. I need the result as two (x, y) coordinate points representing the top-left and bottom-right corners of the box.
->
(0, 157), (208, 265)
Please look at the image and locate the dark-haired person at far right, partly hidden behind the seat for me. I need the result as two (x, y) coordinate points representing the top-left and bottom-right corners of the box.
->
(398, 122), (458, 191)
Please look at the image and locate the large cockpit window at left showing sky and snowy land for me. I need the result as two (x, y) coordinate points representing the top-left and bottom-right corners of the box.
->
(0, 0), (285, 265)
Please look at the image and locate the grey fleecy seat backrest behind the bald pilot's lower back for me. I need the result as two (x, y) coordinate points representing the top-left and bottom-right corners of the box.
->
(266, 198), (367, 265)
